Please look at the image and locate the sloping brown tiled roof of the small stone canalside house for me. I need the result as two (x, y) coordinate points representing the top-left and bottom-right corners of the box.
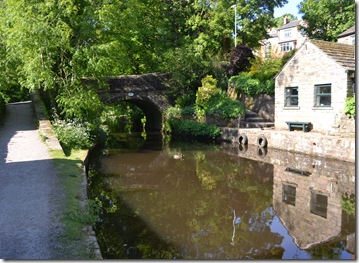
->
(310, 40), (355, 71)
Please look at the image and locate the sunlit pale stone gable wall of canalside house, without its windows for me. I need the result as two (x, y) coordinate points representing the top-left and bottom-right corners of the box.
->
(275, 42), (352, 133)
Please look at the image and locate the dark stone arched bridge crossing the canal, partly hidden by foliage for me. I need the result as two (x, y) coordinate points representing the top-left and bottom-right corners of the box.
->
(84, 73), (171, 131)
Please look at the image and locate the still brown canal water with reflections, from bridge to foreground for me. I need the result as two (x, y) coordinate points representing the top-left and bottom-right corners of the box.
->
(88, 135), (356, 259)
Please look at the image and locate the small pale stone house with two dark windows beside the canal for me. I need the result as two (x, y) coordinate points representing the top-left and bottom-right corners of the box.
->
(275, 40), (355, 135)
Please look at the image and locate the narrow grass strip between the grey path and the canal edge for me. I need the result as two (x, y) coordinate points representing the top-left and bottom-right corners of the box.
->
(51, 150), (100, 259)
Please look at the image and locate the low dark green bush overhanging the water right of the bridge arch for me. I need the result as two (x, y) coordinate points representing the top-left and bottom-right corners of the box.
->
(168, 118), (221, 140)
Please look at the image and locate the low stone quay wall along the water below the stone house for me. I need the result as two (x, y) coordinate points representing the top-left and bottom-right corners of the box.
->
(221, 127), (355, 162)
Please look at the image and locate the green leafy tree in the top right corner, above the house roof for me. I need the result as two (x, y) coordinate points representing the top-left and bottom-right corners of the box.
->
(298, 0), (355, 42)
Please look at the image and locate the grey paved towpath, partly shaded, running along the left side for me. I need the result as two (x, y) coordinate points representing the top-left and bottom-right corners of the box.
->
(0, 102), (61, 259)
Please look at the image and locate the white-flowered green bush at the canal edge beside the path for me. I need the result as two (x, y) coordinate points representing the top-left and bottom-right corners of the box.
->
(53, 119), (91, 151)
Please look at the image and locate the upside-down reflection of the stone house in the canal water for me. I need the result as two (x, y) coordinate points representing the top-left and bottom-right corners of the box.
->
(273, 153), (355, 252)
